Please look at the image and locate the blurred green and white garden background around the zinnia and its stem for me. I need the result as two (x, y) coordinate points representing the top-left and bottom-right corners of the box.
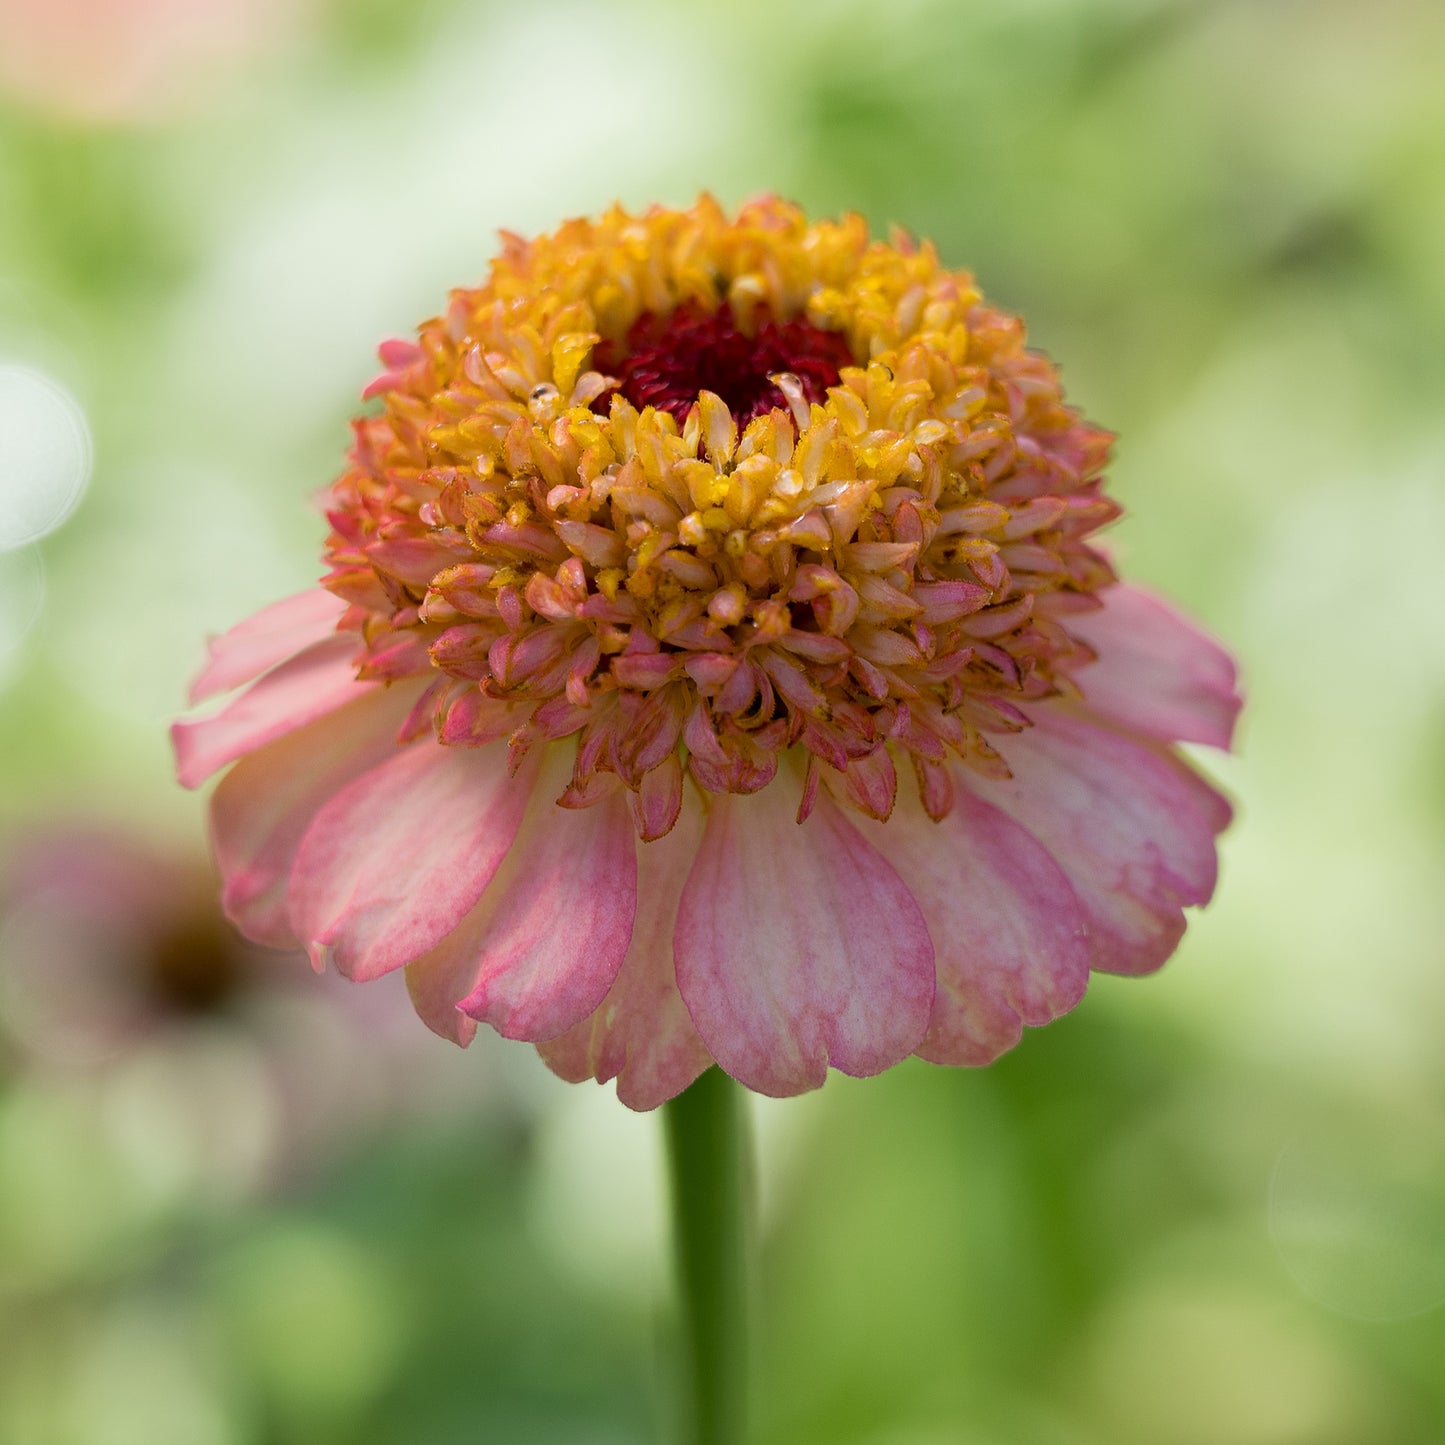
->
(0, 0), (1445, 1445)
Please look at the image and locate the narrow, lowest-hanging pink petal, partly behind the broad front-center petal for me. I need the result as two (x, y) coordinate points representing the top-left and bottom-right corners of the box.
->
(538, 790), (712, 1110)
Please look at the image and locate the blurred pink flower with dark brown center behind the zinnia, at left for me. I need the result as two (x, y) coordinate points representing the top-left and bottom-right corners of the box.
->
(0, 822), (468, 1170)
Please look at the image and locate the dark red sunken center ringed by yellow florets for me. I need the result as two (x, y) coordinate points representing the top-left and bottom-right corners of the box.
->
(592, 305), (853, 426)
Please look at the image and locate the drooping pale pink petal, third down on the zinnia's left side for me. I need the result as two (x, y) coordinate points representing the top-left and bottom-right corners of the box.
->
(211, 686), (418, 948)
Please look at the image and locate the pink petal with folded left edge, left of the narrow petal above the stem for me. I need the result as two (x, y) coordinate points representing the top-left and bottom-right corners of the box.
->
(406, 747), (637, 1043)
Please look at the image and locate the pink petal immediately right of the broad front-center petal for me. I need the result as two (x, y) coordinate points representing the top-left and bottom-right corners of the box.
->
(857, 777), (1090, 1064)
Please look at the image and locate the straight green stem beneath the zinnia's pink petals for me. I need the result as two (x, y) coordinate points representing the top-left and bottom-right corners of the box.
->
(663, 1068), (753, 1445)
